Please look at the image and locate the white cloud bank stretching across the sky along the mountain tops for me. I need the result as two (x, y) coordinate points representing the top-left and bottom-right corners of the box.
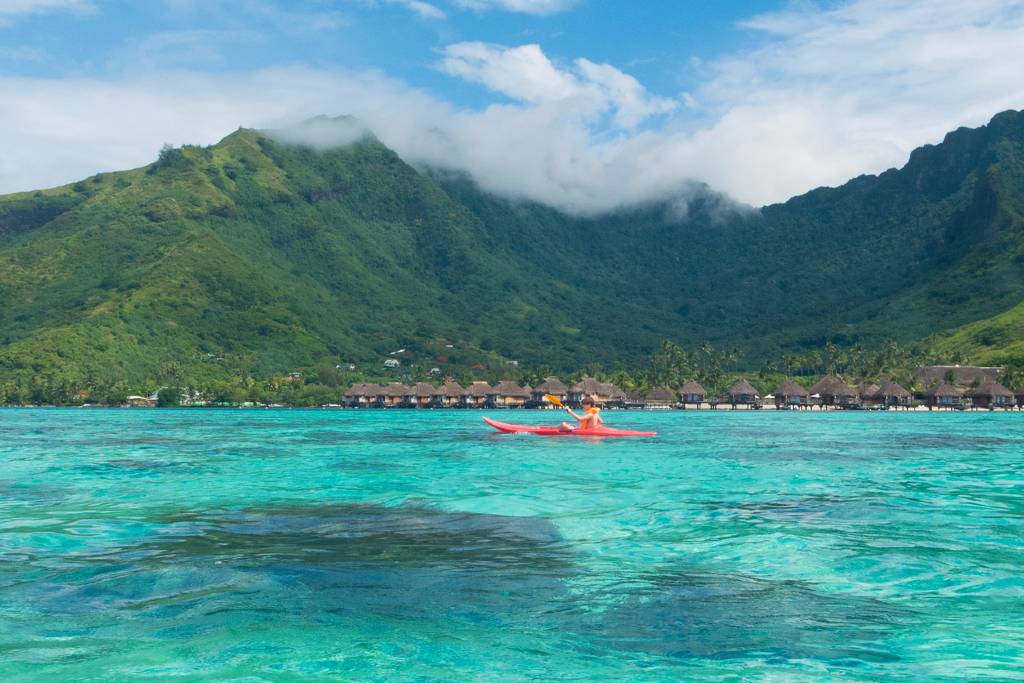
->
(0, 0), (1024, 213)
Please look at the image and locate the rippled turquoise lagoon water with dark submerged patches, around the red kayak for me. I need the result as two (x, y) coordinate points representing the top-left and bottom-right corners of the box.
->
(0, 410), (1024, 681)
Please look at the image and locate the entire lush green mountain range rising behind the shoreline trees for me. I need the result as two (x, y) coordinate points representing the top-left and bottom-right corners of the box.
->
(0, 112), (1024, 383)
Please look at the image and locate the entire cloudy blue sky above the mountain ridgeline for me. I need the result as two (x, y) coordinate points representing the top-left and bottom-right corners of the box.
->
(0, 0), (1024, 211)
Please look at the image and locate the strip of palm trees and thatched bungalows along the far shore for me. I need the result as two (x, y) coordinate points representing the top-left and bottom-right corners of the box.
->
(24, 366), (1024, 411)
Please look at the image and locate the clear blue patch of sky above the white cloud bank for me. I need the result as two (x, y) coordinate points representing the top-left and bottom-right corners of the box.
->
(0, 0), (783, 106)
